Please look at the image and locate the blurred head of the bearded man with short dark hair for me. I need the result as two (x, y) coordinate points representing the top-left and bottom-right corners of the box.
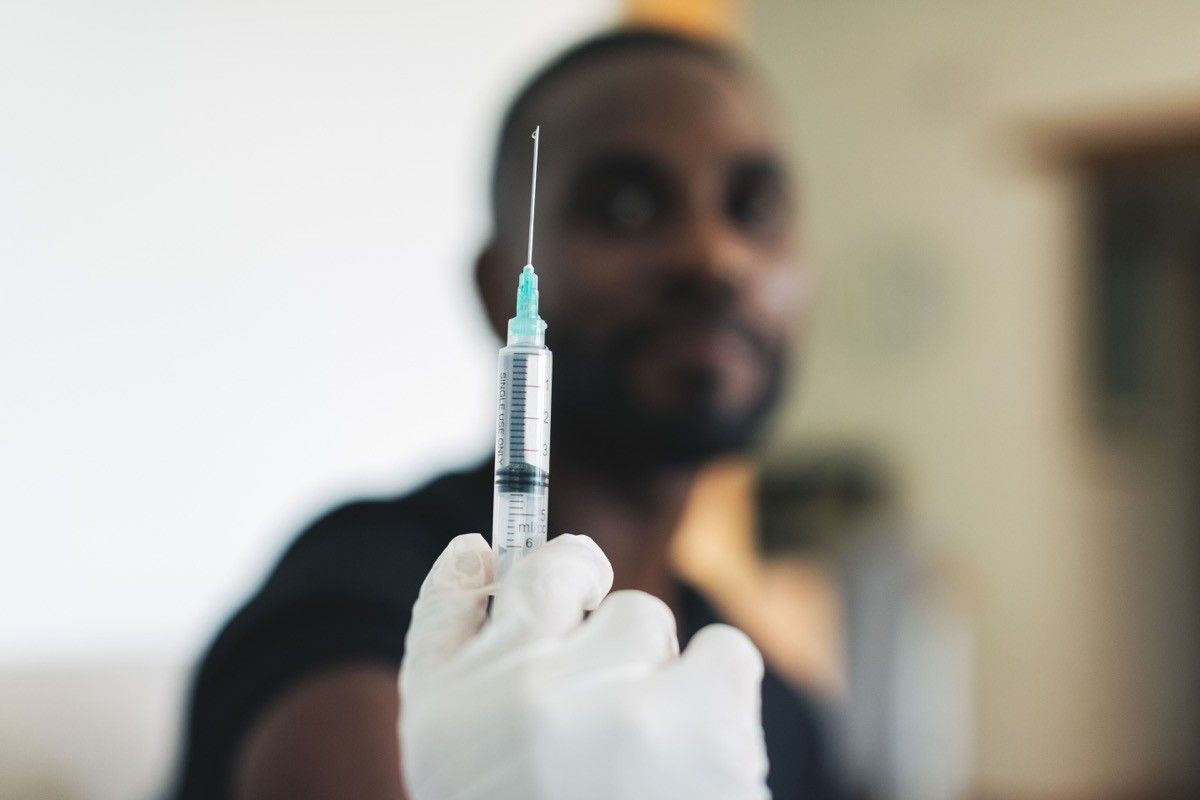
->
(478, 31), (802, 465)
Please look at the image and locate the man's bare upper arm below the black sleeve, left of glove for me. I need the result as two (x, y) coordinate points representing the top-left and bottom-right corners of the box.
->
(234, 664), (407, 800)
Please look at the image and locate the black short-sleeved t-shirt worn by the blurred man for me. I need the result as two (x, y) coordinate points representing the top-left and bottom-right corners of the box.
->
(175, 463), (833, 800)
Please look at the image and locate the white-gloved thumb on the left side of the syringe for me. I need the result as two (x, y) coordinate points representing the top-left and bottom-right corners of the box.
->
(401, 534), (494, 687)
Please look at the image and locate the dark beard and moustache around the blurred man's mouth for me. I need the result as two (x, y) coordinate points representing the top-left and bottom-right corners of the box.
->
(553, 308), (786, 469)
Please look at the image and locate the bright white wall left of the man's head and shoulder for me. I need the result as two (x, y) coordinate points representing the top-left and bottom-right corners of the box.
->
(0, 0), (613, 663)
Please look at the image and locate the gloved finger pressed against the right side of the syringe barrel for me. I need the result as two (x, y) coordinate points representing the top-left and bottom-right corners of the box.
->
(492, 534), (612, 642)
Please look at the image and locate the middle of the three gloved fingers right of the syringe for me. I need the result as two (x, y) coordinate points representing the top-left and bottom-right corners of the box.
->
(556, 589), (679, 674)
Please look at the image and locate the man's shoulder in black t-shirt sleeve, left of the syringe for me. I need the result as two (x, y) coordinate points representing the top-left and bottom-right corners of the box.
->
(171, 467), (491, 796)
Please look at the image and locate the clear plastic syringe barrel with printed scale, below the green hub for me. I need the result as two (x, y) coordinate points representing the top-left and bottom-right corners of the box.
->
(492, 344), (552, 573)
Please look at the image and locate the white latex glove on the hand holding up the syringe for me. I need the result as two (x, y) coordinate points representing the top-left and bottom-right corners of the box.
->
(400, 534), (770, 800)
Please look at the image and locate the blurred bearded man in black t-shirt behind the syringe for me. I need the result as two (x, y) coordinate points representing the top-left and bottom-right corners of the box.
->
(179, 31), (833, 800)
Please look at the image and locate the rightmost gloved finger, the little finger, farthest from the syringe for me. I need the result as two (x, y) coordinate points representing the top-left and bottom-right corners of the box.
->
(661, 625), (763, 724)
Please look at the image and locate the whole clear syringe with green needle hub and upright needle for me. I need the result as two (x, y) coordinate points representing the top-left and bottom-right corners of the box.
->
(492, 126), (552, 581)
